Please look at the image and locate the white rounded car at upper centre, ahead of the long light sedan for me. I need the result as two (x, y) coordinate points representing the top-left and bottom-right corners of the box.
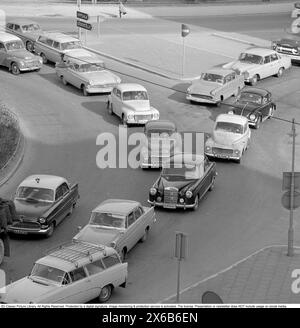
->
(107, 83), (159, 125)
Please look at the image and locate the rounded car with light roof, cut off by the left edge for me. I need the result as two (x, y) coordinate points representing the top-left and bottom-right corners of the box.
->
(0, 32), (43, 75)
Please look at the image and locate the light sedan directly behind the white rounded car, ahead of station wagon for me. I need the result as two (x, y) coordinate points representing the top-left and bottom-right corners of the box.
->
(55, 49), (121, 96)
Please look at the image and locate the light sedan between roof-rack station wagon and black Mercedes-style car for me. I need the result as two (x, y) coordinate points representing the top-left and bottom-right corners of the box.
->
(74, 199), (156, 261)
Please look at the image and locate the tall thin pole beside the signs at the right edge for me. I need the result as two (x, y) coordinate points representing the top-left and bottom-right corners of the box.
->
(287, 118), (296, 256)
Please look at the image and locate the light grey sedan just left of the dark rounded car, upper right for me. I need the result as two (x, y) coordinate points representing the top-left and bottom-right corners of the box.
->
(186, 67), (245, 104)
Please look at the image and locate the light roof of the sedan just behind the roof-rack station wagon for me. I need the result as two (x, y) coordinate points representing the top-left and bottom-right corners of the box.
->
(93, 199), (140, 215)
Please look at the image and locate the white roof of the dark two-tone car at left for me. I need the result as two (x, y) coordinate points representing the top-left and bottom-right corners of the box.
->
(19, 174), (67, 190)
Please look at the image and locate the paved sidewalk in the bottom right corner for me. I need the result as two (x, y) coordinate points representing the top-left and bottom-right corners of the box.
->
(160, 246), (300, 304)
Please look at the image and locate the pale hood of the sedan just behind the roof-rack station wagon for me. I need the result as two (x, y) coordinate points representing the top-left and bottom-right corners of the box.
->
(74, 225), (122, 245)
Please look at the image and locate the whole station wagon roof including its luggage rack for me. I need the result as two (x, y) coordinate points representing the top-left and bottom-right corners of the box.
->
(36, 240), (116, 272)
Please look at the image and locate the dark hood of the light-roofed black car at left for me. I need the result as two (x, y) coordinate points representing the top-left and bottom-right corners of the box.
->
(14, 199), (53, 219)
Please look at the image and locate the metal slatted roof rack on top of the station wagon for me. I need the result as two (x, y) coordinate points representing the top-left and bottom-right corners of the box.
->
(46, 240), (105, 267)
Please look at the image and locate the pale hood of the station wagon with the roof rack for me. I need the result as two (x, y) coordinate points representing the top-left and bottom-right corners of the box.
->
(3, 277), (57, 304)
